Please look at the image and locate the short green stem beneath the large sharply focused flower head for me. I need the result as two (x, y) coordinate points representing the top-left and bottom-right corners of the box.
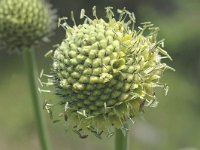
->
(115, 124), (128, 150)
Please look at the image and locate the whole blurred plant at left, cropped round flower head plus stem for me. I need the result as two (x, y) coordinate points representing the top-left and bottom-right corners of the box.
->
(0, 0), (55, 150)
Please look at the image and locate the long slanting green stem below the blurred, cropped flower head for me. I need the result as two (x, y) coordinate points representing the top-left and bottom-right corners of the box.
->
(23, 49), (50, 150)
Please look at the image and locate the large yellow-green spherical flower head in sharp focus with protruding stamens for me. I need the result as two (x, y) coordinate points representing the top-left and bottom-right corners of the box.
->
(42, 7), (173, 136)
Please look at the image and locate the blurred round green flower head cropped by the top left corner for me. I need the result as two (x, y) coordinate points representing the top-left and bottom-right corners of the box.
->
(0, 0), (55, 51)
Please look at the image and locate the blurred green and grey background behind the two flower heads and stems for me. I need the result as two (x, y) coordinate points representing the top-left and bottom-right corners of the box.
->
(0, 0), (200, 150)
